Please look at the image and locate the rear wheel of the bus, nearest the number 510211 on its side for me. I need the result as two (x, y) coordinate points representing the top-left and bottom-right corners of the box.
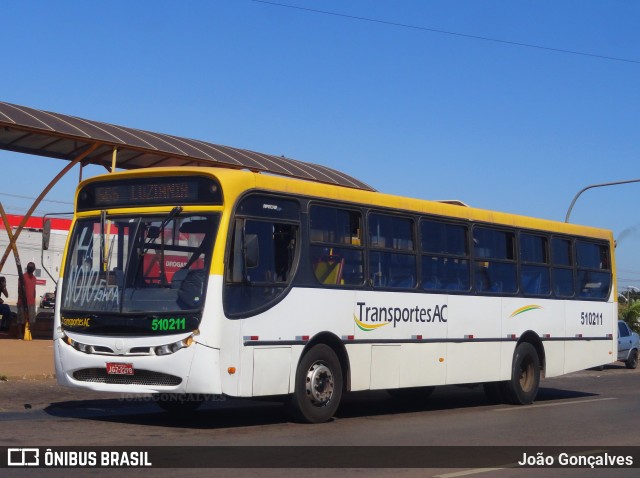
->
(504, 342), (540, 405)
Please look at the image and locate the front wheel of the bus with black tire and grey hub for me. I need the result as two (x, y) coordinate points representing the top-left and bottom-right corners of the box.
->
(289, 344), (343, 423)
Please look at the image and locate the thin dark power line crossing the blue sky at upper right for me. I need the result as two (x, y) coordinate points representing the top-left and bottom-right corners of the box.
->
(250, 0), (640, 64)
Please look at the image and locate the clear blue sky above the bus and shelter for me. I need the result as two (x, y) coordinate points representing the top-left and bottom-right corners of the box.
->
(0, 0), (640, 290)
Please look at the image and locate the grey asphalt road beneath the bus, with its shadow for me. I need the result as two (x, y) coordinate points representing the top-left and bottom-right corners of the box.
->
(0, 364), (640, 478)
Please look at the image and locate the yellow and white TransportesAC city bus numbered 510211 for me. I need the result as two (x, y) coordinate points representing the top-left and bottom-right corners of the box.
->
(54, 167), (617, 422)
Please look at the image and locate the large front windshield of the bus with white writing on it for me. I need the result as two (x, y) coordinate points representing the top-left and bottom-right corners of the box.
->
(61, 212), (220, 315)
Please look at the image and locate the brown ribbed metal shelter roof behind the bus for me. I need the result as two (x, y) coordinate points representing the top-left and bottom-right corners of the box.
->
(0, 102), (374, 191)
